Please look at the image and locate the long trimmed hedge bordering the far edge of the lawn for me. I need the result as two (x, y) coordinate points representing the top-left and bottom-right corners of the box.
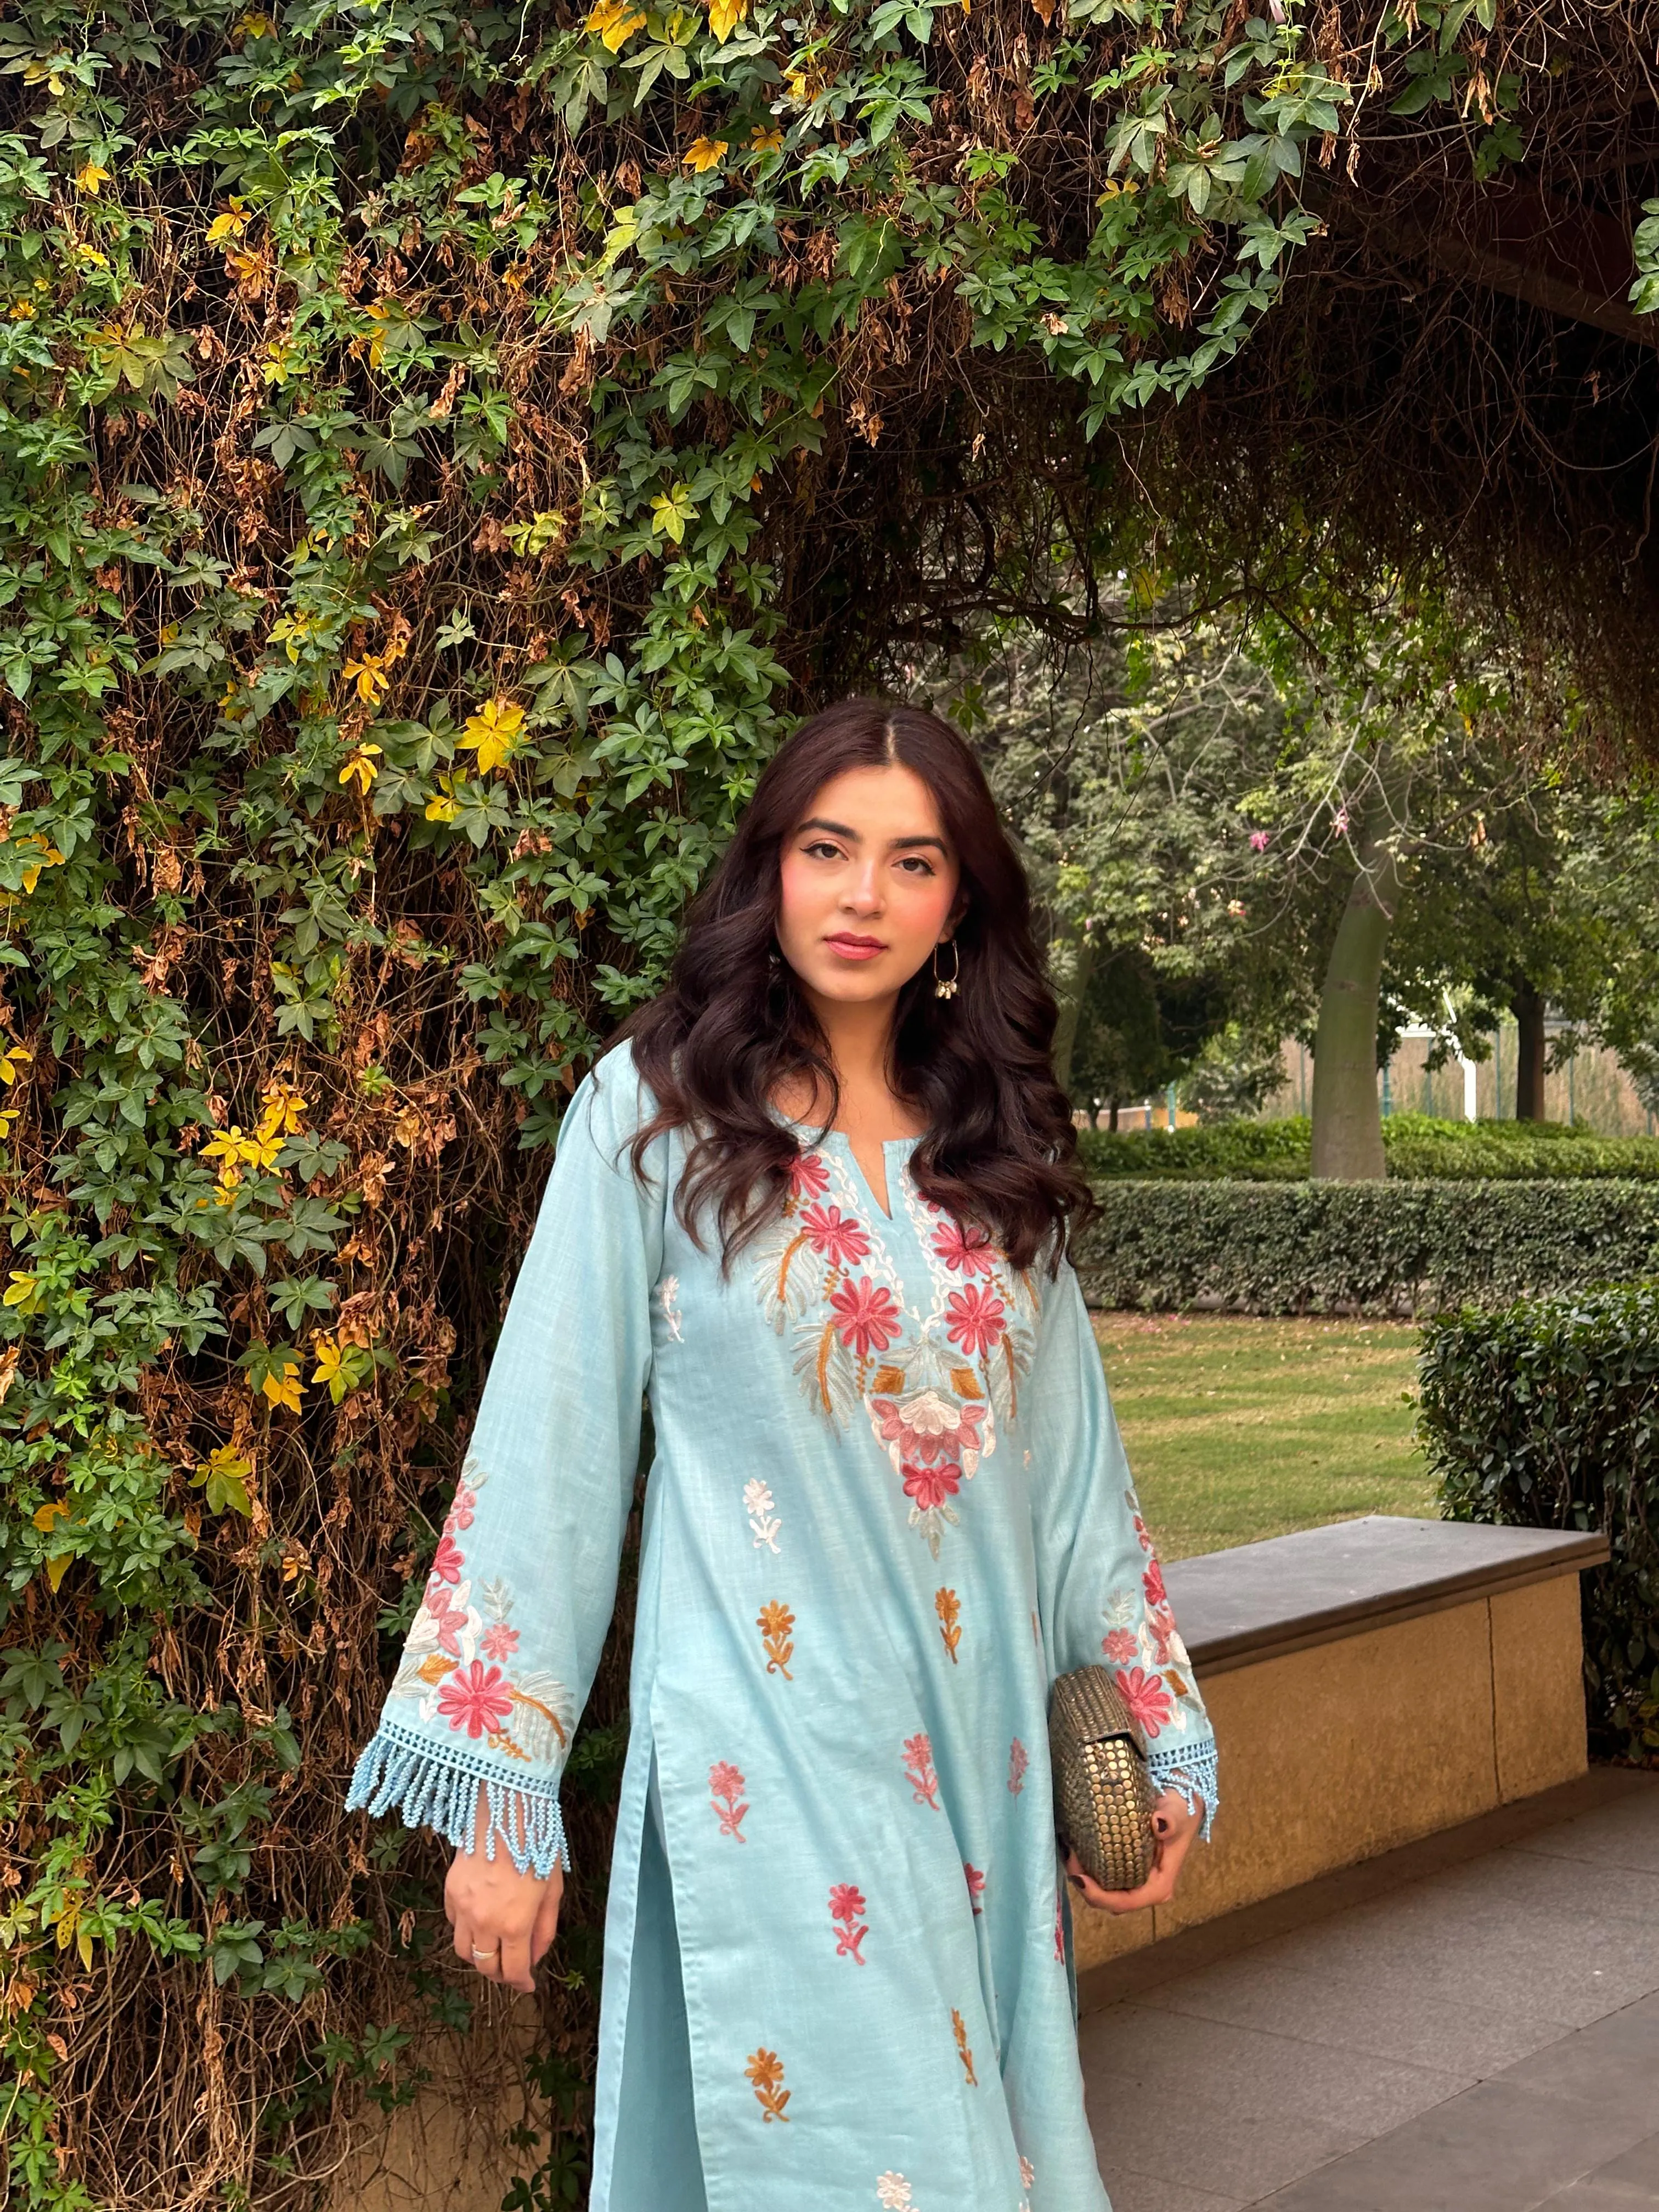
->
(1075, 1181), (1659, 1314)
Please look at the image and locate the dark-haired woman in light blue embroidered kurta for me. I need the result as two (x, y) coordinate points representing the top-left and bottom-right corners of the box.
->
(349, 701), (1215, 2212)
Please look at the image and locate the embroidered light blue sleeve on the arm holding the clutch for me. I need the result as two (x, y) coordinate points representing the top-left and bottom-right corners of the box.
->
(1026, 1261), (1217, 1836)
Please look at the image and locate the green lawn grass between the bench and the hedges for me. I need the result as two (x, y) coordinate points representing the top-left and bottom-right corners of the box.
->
(1095, 1314), (1436, 1560)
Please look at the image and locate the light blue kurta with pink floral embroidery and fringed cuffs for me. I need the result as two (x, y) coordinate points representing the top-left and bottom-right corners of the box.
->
(349, 1046), (1215, 2212)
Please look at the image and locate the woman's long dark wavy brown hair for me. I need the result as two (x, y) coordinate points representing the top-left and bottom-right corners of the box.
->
(606, 699), (1093, 1272)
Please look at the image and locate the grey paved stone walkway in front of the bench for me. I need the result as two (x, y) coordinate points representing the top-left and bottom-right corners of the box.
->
(1080, 1768), (1659, 2212)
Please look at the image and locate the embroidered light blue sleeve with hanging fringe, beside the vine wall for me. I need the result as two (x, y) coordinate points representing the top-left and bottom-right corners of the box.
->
(345, 1046), (666, 1876)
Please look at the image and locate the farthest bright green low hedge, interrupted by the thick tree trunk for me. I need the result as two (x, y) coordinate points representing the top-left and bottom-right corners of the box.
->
(1077, 1113), (1659, 1183)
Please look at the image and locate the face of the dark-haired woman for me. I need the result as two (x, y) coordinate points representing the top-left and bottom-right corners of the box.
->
(778, 765), (967, 1005)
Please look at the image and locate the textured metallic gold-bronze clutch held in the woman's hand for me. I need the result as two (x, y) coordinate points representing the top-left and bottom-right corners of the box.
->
(1048, 1666), (1157, 1889)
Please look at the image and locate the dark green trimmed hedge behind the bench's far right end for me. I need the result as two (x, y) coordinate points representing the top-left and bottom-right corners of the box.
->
(1418, 1283), (1659, 1760)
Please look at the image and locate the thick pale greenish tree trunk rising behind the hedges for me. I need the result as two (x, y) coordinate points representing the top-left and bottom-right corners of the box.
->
(1314, 838), (1400, 1183)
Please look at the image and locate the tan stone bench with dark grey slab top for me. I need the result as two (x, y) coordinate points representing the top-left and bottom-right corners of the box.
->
(1073, 1513), (1608, 1968)
